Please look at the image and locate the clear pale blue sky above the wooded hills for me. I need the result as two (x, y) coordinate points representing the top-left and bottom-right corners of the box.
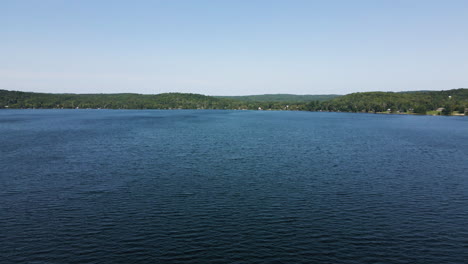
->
(0, 0), (468, 95)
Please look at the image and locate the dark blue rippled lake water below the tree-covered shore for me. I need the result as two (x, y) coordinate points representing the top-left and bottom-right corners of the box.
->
(0, 110), (468, 264)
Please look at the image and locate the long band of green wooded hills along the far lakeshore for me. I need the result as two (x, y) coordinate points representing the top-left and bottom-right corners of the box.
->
(0, 89), (468, 115)
